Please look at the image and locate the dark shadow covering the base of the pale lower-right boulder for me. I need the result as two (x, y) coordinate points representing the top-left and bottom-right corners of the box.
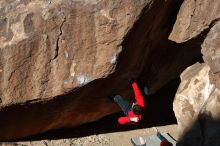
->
(177, 113), (220, 146)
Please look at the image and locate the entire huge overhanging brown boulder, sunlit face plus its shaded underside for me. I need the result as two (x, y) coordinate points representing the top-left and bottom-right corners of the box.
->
(0, 0), (200, 140)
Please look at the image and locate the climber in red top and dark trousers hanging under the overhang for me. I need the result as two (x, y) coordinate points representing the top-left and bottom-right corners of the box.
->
(109, 82), (146, 125)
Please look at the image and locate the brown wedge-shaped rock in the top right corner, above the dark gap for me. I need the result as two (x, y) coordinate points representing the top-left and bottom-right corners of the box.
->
(169, 0), (220, 43)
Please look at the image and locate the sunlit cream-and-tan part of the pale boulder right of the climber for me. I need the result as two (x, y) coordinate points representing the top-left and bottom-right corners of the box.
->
(173, 63), (214, 137)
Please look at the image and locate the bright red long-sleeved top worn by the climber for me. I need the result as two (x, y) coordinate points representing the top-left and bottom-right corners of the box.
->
(118, 82), (145, 125)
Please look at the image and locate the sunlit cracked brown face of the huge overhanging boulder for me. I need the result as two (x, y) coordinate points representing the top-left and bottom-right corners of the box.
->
(0, 0), (144, 106)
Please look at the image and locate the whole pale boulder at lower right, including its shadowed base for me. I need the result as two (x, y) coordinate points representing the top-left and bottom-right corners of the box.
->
(173, 63), (220, 146)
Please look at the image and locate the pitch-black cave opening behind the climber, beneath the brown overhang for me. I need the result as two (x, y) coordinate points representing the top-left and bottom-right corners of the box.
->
(19, 78), (180, 141)
